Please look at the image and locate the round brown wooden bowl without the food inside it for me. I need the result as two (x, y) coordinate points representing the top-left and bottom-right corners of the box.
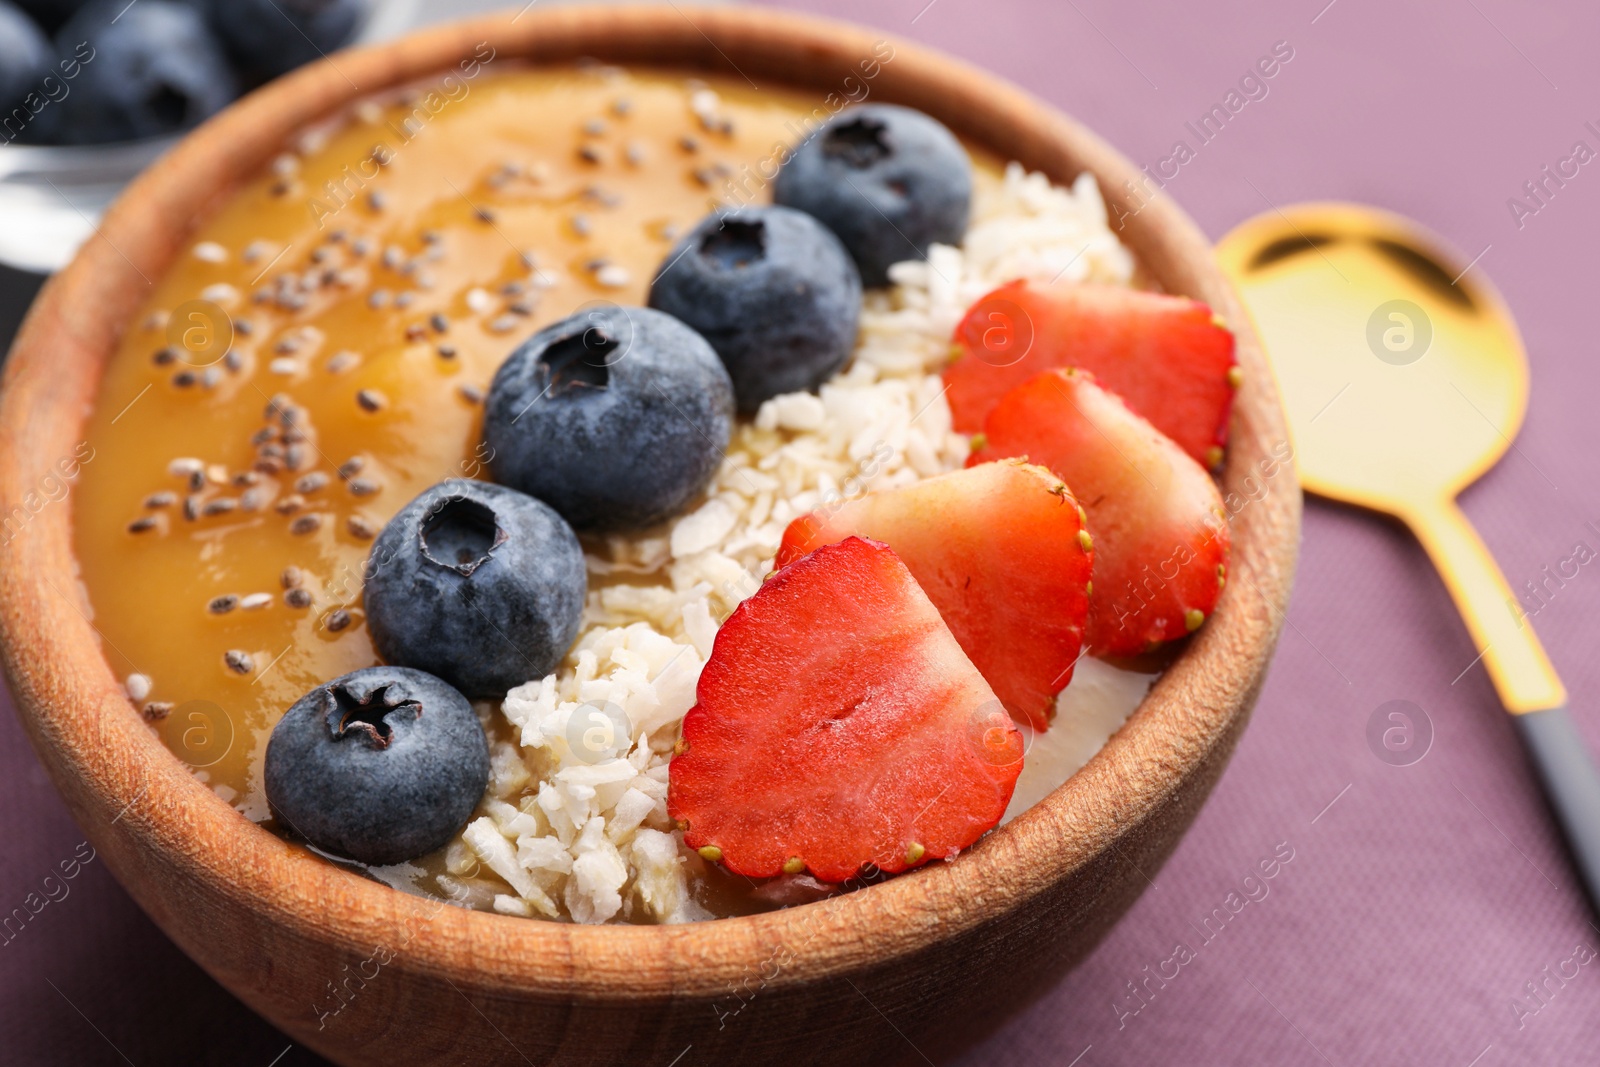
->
(0, 6), (1299, 1067)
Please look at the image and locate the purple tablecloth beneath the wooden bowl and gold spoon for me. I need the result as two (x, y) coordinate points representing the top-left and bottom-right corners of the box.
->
(0, 0), (1600, 1067)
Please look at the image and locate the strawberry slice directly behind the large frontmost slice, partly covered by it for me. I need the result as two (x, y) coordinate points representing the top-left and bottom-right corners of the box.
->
(778, 459), (1093, 729)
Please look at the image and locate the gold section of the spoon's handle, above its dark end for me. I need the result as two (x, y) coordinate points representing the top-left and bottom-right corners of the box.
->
(1403, 501), (1561, 716)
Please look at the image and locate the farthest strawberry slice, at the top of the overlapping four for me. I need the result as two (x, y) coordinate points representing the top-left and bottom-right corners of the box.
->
(944, 282), (1238, 470)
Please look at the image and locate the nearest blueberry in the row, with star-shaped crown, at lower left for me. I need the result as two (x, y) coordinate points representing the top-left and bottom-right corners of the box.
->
(266, 667), (490, 865)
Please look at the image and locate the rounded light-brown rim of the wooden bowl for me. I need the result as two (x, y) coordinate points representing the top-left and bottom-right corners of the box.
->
(0, 3), (1299, 1000)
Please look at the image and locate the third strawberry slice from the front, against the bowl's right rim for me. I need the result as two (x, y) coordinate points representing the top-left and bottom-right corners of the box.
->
(968, 371), (1229, 656)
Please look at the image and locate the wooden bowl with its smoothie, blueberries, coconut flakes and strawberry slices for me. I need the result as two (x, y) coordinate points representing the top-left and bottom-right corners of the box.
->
(0, 8), (1298, 1062)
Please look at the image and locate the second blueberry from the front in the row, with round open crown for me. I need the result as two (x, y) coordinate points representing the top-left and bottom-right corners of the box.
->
(363, 478), (589, 697)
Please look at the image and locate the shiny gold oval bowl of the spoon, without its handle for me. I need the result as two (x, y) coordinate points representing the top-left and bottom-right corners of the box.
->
(1219, 203), (1528, 515)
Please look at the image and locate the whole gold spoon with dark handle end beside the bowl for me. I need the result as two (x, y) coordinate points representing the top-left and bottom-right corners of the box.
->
(1218, 203), (1600, 910)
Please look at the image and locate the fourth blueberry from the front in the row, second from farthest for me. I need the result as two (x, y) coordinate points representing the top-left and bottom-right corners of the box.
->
(650, 208), (861, 411)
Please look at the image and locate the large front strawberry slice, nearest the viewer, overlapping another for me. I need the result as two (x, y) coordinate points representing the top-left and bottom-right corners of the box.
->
(667, 537), (1022, 881)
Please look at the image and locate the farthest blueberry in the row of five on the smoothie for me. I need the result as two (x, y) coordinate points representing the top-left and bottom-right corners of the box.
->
(773, 104), (973, 286)
